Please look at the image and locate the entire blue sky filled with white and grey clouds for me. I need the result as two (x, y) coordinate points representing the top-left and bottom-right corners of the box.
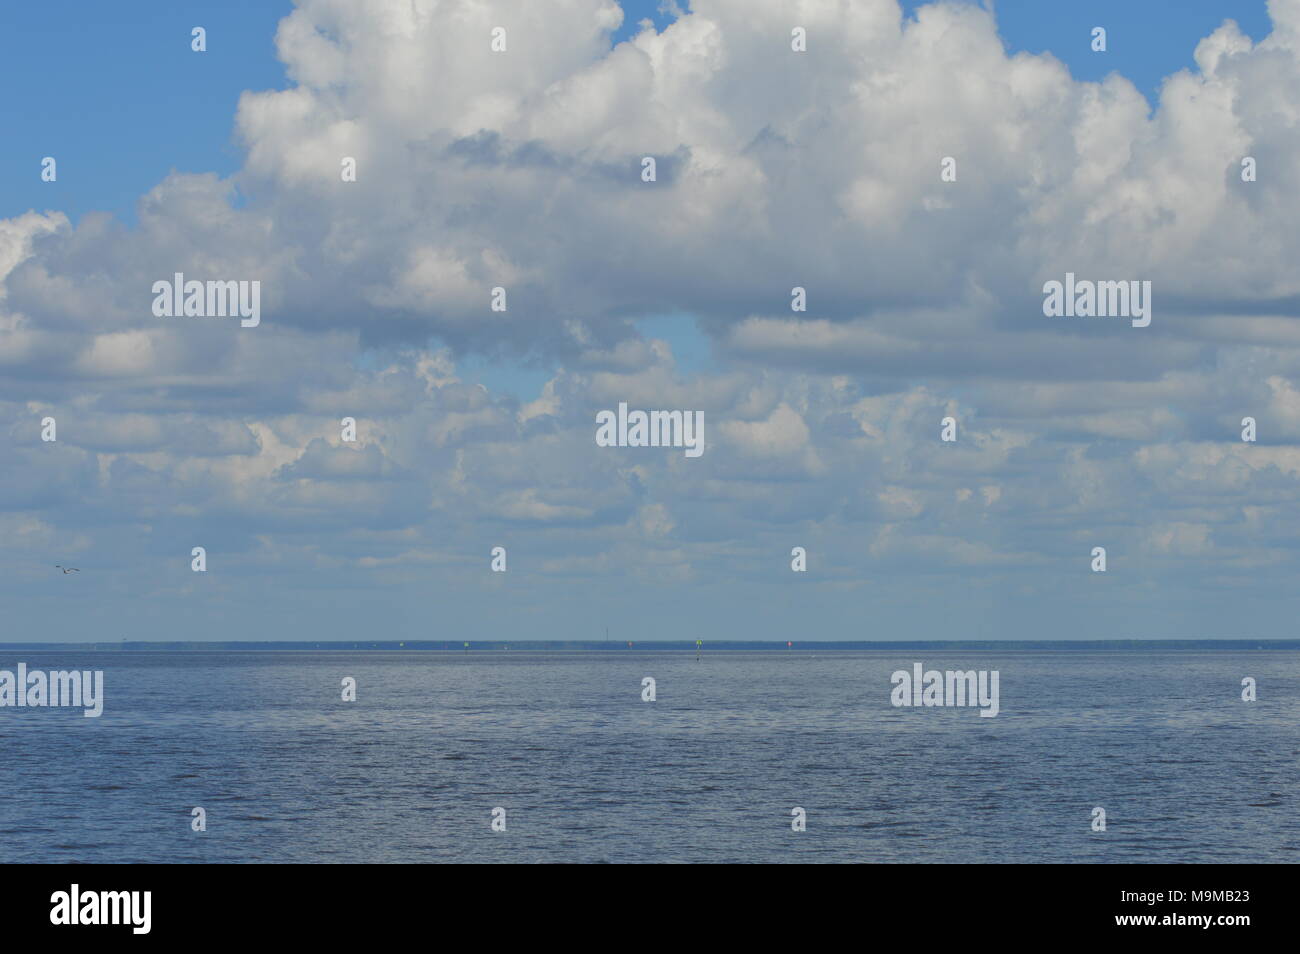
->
(0, 0), (1300, 639)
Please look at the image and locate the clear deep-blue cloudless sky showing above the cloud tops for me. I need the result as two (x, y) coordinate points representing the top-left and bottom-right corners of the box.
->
(0, 0), (1268, 221)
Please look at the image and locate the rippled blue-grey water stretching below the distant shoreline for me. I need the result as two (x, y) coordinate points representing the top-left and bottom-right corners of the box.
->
(0, 649), (1300, 863)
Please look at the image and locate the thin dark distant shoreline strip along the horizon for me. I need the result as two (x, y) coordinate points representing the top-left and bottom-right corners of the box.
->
(0, 639), (1300, 654)
